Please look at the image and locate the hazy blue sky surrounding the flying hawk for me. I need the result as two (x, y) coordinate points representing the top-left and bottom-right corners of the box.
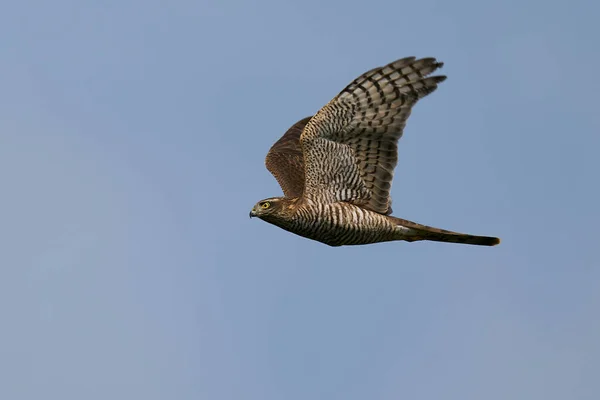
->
(0, 0), (600, 400)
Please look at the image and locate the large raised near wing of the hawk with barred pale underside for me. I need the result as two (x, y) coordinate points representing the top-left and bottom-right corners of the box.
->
(300, 57), (446, 214)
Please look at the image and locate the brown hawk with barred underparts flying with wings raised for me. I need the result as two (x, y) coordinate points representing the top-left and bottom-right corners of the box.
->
(250, 56), (500, 247)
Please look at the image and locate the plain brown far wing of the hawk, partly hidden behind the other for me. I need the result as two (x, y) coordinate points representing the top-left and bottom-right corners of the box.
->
(265, 117), (312, 198)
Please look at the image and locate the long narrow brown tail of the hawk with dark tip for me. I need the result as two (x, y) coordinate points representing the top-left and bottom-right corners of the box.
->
(388, 216), (500, 246)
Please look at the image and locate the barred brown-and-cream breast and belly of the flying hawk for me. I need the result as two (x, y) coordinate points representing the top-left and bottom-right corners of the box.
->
(290, 202), (398, 246)
